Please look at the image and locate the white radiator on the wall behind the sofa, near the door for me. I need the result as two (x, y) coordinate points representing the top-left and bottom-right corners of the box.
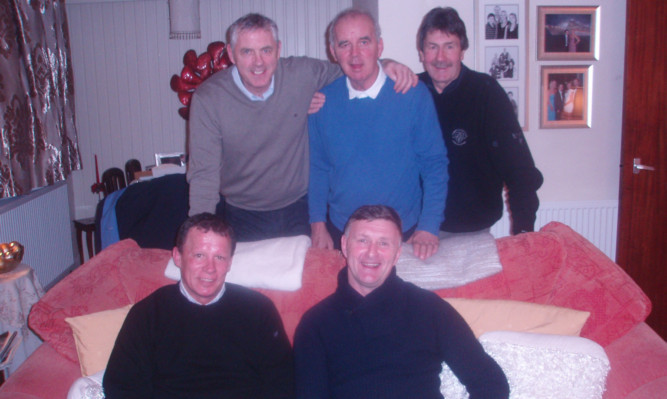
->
(491, 200), (618, 260)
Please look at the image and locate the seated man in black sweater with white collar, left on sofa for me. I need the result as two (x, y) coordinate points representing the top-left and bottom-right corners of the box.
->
(103, 213), (294, 399)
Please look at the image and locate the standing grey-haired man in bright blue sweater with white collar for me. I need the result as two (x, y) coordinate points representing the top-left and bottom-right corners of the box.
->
(308, 9), (447, 259)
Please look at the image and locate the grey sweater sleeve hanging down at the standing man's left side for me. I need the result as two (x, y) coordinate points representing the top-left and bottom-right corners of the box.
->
(187, 88), (223, 216)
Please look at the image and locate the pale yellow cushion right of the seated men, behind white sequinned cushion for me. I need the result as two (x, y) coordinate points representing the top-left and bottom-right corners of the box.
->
(443, 298), (590, 338)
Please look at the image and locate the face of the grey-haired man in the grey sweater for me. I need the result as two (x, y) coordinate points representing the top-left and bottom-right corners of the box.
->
(229, 29), (280, 96)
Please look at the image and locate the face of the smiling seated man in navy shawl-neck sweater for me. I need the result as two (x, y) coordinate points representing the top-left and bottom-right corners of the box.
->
(341, 219), (401, 296)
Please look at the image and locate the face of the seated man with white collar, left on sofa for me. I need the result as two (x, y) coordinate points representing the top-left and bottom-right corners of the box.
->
(172, 228), (232, 305)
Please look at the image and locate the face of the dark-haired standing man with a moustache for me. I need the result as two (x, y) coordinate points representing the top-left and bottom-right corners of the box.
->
(419, 30), (465, 93)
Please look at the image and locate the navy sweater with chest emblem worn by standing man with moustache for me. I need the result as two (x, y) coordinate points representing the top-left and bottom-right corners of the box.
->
(419, 65), (543, 234)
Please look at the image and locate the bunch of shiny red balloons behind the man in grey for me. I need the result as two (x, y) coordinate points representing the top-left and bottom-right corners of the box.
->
(169, 42), (232, 120)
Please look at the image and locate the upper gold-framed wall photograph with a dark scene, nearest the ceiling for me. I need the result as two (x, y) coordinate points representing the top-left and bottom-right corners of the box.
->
(537, 7), (600, 61)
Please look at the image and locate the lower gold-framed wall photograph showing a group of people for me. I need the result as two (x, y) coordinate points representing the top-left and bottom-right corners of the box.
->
(540, 65), (593, 129)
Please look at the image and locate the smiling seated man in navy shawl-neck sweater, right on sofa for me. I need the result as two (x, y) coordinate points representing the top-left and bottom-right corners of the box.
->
(294, 205), (509, 399)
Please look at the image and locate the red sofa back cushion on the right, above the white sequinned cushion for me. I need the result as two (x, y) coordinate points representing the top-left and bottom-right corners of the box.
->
(436, 222), (651, 346)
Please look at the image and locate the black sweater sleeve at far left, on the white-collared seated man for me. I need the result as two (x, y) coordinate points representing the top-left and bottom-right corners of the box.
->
(102, 305), (154, 399)
